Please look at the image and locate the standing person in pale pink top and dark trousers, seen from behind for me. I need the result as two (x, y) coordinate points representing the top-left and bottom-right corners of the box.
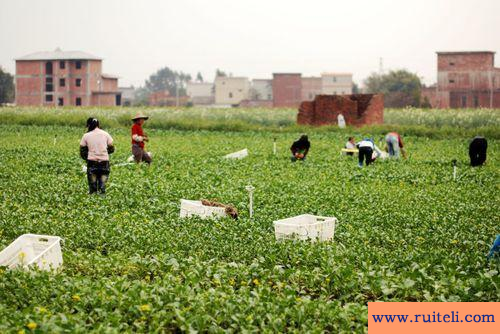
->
(80, 118), (115, 194)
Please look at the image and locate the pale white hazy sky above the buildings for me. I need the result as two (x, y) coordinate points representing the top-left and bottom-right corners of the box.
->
(0, 0), (500, 86)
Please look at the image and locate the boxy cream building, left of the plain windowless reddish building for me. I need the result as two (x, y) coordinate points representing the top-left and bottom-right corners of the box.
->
(214, 77), (250, 105)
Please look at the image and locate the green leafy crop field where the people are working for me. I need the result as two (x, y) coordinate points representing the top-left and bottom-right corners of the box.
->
(0, 109), (500, 333)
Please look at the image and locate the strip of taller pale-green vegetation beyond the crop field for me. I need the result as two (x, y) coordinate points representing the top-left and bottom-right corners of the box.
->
(0, 107), (500, 139)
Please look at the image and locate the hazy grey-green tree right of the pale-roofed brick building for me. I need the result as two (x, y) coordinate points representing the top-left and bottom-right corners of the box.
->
(146, 67), (191, 96)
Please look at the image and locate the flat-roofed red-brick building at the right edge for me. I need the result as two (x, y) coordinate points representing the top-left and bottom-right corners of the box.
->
(434, 51), (500, 108)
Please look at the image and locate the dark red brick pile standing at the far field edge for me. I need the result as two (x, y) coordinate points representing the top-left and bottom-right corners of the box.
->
(297, 94), (384, 126)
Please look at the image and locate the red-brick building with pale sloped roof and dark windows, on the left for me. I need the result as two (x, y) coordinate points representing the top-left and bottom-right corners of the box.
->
(16, 49), (121, 106)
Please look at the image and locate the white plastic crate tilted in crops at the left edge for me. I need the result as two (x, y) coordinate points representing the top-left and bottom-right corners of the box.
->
(0, 234), (63, 270)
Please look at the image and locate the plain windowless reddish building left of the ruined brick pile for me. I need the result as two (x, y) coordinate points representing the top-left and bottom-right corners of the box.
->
(273, 73), (302, 108)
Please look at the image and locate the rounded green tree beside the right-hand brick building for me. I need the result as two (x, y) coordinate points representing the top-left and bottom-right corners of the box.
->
(365, 70), (422, 108)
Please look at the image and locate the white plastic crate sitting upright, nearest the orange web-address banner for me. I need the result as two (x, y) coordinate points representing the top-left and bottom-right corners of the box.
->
(274, 214), (337, 241)
